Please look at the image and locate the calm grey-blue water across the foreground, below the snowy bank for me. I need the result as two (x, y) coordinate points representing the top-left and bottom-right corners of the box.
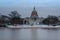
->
(0, 28), (60, 40)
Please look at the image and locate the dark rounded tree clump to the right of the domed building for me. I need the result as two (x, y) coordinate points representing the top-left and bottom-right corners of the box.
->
(43, 16), (58, 25)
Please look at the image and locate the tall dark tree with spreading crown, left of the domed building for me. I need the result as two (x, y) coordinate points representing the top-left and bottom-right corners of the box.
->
(9, 11), (23, 25)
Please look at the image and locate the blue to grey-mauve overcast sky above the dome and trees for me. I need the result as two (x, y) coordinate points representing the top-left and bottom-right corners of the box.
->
(0, 0), (60, 17)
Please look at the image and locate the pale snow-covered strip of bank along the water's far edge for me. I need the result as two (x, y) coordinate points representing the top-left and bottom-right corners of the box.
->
(8, 25), (60, 28)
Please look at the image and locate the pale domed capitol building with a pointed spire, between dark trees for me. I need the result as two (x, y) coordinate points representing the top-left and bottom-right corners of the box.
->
(24, 7), (44, 25)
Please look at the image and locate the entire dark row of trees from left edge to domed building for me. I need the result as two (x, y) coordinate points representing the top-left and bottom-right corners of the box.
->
(0, 11), (23, 27)
